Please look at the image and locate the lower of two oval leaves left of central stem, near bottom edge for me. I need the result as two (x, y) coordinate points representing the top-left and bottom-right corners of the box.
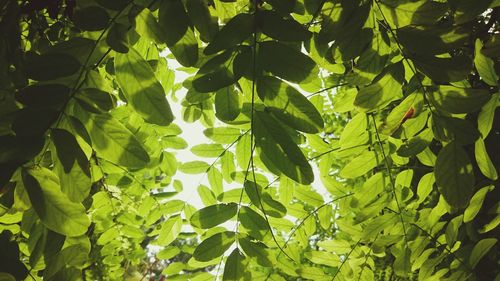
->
(193, 231), (235, 262)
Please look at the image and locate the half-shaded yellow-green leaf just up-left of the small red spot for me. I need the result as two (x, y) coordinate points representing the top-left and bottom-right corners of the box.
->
(354, 64), (403, 112)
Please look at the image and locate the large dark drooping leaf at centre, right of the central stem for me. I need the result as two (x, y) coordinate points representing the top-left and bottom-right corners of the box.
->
(254, 111), (314, 184)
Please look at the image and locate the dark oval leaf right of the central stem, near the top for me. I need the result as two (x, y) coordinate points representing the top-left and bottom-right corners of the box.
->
(257, 41), (318, 83)
